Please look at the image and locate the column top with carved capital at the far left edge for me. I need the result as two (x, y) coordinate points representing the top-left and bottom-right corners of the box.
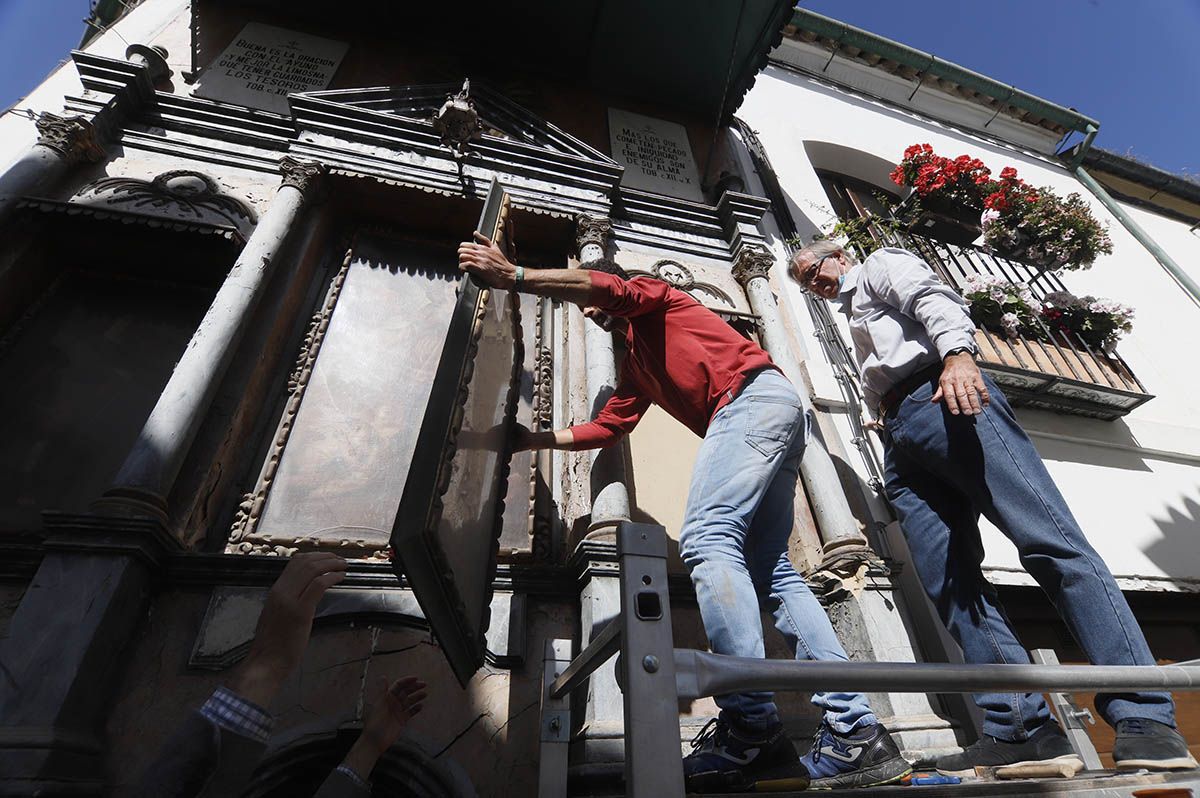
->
(0, 113), (104, 221)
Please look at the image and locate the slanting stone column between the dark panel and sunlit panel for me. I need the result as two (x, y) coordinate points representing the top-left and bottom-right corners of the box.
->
(95, 156), (326, 522)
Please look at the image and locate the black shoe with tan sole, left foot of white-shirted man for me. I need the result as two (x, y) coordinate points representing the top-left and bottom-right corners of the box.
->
(936, 720), (1084, 779)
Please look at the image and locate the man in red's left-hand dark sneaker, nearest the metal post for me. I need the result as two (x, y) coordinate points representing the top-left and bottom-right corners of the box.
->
(683, 718), (809, 792)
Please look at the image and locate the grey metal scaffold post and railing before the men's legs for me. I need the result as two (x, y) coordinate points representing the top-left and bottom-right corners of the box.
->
(539, 521), (1200, 798)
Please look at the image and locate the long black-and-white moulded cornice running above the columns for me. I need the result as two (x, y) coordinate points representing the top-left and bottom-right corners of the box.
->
(58, 53), (764, 253)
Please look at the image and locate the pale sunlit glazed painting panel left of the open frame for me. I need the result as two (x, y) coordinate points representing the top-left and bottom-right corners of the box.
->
(253, 239), (457, 554)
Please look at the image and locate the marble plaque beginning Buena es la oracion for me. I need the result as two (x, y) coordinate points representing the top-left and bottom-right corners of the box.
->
(196, 23), (349, 114)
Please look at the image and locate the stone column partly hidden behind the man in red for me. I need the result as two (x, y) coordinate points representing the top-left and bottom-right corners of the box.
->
(576, 214), (629, 538)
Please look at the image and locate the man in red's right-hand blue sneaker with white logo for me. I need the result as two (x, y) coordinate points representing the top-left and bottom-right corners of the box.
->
(800, 721), (912, 790)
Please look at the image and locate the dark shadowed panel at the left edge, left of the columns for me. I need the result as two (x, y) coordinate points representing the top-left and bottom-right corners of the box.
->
(0, 270), (212, 529)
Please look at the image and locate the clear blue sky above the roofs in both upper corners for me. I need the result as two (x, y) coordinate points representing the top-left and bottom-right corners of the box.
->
(0, 0), (1200, 175)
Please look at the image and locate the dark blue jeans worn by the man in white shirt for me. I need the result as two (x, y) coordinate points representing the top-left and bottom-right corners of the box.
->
(884, 376), (1175, 740)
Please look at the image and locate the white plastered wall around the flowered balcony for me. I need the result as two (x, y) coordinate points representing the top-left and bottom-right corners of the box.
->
(738, 66), (1200, 589)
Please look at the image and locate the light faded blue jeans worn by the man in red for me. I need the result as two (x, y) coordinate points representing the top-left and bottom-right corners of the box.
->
(679, 368), (875, 733)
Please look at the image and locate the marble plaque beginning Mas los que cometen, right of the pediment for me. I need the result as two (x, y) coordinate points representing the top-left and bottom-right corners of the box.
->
(608, 108), (704, 203)
